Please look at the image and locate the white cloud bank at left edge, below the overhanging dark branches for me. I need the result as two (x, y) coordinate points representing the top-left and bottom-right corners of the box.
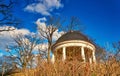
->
(0, 26), (30, 50)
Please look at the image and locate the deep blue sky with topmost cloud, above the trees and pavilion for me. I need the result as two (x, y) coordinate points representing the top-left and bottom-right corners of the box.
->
(0, 0), (120, 55)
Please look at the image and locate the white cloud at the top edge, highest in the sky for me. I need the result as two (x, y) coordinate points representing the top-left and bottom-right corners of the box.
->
(24, 0), (63, 16)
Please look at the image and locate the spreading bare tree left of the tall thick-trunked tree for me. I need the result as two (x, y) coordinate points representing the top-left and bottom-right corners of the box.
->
(6, 34), (40, 68)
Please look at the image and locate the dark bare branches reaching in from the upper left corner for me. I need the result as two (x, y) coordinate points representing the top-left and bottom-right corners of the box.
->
(0, 0), (20, 32)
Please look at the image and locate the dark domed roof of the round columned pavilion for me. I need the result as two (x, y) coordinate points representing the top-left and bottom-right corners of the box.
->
(56, 31), (90, 43)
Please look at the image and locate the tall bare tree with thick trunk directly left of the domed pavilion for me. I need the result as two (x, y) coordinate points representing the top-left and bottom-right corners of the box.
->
(38, 17), (64, 63)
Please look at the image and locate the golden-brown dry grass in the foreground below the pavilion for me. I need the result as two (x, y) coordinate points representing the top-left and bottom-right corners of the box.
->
(10, 59), (120, 76)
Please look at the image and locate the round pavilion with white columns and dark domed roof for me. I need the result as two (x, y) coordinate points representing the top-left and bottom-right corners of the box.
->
(51, 31), (96, 64)
